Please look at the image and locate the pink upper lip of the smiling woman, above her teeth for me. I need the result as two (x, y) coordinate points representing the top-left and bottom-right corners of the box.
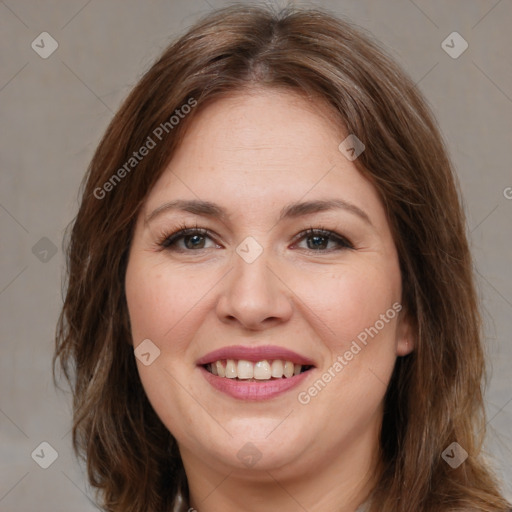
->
(196, 345), (315, 366)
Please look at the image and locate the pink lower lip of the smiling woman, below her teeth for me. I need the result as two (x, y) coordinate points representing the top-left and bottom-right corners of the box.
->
(199, 366), (312, 400)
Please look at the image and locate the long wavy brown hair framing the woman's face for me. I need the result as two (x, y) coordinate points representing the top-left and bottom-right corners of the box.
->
(54, 5), (509, 512)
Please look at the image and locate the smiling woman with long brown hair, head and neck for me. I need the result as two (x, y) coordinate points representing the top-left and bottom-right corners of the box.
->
(55, 5), (510, 512)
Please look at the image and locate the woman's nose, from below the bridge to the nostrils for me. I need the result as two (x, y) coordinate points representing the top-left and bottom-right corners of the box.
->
(216, 251), (293, 331)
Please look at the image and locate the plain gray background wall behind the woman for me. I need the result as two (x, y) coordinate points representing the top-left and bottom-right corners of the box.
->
(0, 0), (512, 512)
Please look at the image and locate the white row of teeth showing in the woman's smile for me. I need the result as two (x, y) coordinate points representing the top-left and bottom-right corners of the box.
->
(207, 359), (303, 380)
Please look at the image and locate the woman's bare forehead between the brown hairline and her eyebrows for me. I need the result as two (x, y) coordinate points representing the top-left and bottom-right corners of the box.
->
(142, 89), (383, 230)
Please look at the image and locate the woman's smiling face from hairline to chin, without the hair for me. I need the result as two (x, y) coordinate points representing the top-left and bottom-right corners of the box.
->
(126, 90), (412, 484)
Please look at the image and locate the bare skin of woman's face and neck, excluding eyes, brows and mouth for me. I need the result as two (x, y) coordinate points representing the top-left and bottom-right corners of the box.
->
(126, 89), (414, 512)
